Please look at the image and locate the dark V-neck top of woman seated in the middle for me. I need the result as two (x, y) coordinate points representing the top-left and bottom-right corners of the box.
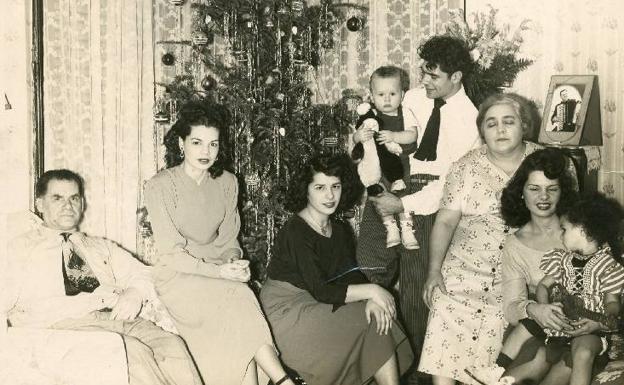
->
(268, 215), (368, 305)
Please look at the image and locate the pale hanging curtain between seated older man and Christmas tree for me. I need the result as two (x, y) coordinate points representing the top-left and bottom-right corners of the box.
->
(43, 0), (155, 250)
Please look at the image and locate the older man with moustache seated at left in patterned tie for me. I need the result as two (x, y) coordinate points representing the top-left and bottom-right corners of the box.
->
(2, 170), (201, 385)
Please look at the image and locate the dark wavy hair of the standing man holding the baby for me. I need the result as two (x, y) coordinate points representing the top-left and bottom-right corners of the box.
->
(418, 35), (474, 80)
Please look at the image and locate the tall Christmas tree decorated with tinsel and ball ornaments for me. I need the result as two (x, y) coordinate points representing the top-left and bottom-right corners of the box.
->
(149, 0), (366, 282)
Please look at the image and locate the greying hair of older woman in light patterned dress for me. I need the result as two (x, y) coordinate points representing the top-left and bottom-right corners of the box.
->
(477, 92), (537, 140)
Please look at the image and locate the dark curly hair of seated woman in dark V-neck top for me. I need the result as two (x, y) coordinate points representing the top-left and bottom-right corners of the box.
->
(285, 154), (364, 215)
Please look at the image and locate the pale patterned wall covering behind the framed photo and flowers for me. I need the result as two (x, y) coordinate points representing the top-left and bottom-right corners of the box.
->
(466, 0), (624, 203)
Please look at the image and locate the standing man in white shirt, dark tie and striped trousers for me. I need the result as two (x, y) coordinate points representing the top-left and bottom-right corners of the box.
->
(358, 36), (480, 383)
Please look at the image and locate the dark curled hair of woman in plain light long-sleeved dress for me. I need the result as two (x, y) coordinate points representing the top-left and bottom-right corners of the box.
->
(164, 101), (229, 178)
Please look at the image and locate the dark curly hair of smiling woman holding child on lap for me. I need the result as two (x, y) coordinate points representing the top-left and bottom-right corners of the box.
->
(501, 148), (577, 227)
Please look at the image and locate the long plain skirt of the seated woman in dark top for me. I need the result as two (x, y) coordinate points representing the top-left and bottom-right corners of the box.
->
(260, 279), (413, 385)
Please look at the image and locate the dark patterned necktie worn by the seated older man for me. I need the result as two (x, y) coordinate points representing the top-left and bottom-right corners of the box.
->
(61, 233), (100, 295)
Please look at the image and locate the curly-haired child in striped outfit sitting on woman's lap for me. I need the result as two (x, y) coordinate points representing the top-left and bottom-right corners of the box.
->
(536, 193), (624, 385)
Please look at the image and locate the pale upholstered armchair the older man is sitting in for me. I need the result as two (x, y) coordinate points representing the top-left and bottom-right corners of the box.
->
(0, 211), (177, 385)
